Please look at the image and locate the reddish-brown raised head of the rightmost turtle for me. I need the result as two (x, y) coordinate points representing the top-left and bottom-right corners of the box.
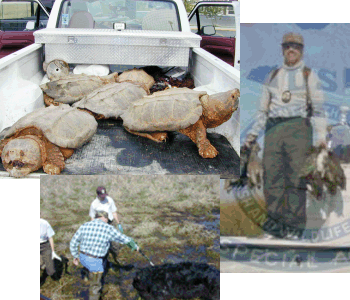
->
(200, 89), (240, 128)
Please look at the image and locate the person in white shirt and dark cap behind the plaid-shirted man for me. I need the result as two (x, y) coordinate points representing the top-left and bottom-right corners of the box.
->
(89, 186), (124, 265)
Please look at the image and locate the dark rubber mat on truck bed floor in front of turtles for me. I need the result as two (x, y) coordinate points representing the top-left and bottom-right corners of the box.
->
(0, 120), (239, 178)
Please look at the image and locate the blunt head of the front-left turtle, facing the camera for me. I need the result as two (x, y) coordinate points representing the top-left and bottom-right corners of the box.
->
(1, 138), (42, 177)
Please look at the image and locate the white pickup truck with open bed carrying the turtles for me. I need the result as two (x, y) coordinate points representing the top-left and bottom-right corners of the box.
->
(0, 0), (240, 177)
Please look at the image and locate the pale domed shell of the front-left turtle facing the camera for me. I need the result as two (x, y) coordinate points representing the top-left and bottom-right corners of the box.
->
(4, 104), (97, 148)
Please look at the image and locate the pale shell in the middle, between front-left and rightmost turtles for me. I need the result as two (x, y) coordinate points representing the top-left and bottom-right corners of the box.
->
(73, 82), (147, 118)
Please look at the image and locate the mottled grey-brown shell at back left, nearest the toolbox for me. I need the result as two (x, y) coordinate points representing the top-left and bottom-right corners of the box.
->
(40, 73), (117, 104)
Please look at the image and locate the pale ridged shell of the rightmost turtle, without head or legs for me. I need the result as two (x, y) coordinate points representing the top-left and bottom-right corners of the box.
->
(121, 88), (207, 131)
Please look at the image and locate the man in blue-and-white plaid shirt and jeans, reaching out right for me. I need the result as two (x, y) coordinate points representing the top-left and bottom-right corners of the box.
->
(70, 211), (139, 300)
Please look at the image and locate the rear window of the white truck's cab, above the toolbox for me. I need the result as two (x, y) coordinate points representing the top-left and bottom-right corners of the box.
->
(58, 0), (180, 31)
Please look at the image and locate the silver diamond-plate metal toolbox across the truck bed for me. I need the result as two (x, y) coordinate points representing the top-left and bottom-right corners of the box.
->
(34, 28), (201, 67)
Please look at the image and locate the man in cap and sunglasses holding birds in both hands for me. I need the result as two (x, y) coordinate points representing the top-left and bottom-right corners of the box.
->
(244, 33), (327, 239)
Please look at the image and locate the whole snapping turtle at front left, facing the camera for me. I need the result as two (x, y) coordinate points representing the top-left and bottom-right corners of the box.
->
(0, 104), (97, 177)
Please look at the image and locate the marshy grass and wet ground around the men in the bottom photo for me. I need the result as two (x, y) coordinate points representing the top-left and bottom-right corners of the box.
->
(40, 175), (220, 300)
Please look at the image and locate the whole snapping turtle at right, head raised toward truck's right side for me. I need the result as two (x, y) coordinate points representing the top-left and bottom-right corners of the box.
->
(121, 88), (240, 158)
